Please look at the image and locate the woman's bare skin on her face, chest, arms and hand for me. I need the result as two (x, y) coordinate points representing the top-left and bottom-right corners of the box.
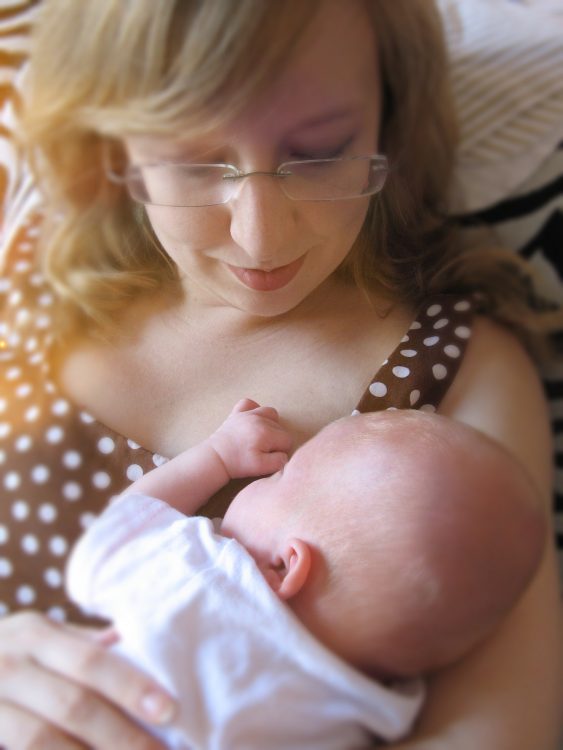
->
(0, 0), (562, 750)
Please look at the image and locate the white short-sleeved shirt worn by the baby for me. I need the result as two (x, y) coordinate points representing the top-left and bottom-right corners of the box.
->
(67, 494), (423, 750)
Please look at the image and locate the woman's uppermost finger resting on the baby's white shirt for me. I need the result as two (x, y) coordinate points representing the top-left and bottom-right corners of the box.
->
(0, 613), (175, 724)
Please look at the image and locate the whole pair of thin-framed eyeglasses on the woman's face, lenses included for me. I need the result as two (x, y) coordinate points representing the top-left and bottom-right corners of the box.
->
(106, 154), (389, 208)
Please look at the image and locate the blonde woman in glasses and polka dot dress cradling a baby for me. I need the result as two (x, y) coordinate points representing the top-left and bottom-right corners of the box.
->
(0, 0), (560, 750)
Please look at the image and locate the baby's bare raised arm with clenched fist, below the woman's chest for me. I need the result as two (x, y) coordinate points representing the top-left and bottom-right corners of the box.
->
(123, 399), (291, 515)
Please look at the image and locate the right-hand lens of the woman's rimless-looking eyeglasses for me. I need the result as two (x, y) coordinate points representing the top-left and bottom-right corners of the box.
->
(279, 156), (387, 201)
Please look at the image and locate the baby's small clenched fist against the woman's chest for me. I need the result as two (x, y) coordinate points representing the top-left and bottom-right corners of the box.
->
(209, 398), (292, 479)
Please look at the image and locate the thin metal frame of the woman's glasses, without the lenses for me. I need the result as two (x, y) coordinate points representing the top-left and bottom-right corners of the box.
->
(104, 152), (389, 208)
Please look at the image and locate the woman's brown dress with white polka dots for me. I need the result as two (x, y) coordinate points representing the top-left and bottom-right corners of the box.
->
(0, 220), (472, 622)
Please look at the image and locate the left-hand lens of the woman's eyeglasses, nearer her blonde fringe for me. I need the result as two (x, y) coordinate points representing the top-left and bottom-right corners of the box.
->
(126, 164), (236, 207)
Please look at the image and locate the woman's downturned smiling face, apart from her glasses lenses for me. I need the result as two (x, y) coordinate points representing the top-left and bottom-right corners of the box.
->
(126, 0), (380, 317)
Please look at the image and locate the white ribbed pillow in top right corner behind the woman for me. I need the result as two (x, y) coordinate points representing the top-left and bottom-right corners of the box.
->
(440, 0), (563, 212)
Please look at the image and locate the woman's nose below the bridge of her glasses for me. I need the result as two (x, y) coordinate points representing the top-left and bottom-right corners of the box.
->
(229, 174), (297, 270)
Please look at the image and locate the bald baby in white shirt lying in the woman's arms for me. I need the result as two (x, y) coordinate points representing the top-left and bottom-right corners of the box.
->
(67, 399), (545, 750)
